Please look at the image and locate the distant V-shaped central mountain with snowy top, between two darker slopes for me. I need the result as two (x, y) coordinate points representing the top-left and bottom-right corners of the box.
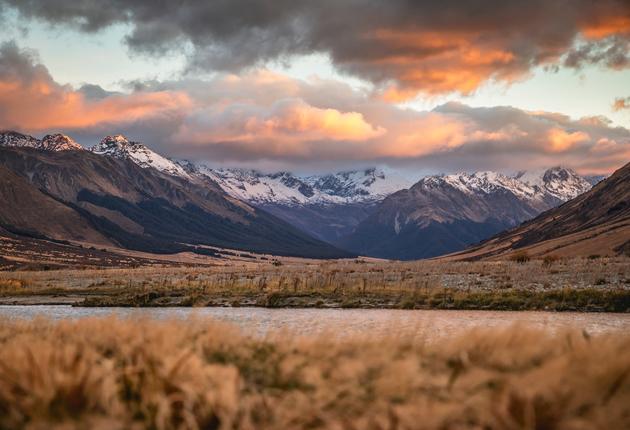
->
(182, 163), (420, 243)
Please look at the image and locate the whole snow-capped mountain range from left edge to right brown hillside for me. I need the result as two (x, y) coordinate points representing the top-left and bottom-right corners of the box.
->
(0, 128), (612, 259)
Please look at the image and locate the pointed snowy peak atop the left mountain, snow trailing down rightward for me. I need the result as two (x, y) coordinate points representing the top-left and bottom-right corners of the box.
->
(90, 134), (190, 178)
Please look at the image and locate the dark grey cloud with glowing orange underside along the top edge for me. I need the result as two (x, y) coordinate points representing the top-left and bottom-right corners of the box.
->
(0, 0), (630, 97)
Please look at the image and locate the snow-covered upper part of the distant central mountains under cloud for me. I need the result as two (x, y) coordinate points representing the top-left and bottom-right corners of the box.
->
(186, 164), (413, 206)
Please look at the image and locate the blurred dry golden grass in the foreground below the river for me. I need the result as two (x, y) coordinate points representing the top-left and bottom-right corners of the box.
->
(0, 319), (630, 430)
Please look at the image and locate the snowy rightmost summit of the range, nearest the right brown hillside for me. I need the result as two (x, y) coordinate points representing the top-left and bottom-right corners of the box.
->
(515, 167), (592, 202)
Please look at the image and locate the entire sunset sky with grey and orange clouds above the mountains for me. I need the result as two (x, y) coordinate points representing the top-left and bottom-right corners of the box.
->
(0, 0), (630, 174)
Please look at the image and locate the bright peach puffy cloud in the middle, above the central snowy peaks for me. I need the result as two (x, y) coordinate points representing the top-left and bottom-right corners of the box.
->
(174, 99), (386, 157)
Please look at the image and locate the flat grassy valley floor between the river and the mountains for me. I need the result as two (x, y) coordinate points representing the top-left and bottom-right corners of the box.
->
(0, 256), (630, 312)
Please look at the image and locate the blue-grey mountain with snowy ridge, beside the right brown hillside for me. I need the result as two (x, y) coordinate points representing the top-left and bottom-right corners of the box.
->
(336, 168), (590, 260)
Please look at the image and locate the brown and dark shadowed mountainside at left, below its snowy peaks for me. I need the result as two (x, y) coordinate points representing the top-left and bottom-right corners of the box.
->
(0, 136), (348, 258)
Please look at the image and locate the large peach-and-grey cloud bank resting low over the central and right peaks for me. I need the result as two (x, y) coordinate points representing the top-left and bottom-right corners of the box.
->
(132, 70), (630, 172)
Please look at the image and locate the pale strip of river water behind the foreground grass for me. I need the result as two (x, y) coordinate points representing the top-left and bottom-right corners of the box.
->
(0, 306), (630, 339)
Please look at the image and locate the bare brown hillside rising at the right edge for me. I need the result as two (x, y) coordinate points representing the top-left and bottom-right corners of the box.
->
(454, 160), (630, 259)
